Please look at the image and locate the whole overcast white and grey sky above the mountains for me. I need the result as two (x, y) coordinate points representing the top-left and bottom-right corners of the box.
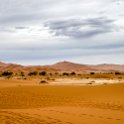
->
(0, 0), (124, 65)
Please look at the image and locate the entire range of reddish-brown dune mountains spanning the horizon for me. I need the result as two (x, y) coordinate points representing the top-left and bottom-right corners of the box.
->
(0, 61), (124, 72)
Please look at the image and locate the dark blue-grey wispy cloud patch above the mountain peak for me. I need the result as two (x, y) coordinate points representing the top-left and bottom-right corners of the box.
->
(45, 18), (114, 38)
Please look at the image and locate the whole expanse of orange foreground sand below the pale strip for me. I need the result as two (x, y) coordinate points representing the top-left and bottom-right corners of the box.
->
(0, 80), (124, 124)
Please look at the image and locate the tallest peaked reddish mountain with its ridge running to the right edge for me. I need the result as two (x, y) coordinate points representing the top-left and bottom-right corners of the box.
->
(50, 61), (124, 71)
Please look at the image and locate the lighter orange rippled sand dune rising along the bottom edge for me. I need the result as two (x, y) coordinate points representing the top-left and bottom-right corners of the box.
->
(0, 107), (124, 124)
